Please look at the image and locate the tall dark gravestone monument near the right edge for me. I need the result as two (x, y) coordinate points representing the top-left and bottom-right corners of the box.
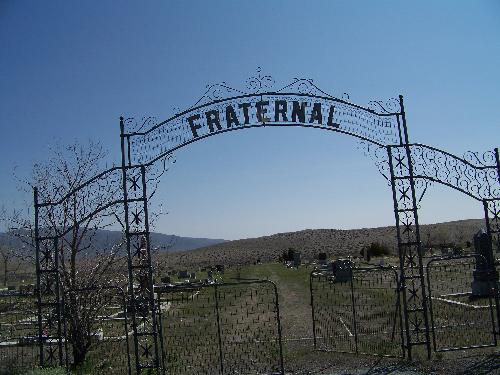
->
(471, 229), (498, 297)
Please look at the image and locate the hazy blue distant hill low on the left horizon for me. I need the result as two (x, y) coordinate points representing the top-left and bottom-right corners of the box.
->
(0, 230), (225, 252)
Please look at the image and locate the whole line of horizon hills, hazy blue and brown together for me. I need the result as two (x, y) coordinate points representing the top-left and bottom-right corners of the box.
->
(0, 219), (492, 268)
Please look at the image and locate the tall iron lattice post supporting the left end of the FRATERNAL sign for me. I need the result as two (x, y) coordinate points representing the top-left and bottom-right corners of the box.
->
(120, 117), (160, 373)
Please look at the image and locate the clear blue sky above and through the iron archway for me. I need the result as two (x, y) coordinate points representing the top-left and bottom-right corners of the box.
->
(0, 0), (500, 239)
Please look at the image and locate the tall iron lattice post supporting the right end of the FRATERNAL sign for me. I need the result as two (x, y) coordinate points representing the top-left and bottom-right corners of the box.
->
(387, 95), (431, 360)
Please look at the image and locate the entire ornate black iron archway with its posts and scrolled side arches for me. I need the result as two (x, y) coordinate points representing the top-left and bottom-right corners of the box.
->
(35, 70), (500, 372)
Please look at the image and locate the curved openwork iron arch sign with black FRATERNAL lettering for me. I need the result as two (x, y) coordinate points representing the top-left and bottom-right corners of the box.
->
(125, 76), (402, 164)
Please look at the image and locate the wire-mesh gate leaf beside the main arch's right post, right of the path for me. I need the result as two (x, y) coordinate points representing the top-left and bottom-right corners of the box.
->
(310, 267), (404, 357)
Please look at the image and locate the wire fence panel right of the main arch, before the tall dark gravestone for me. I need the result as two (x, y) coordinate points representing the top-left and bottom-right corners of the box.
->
(427, 256), (496, 352)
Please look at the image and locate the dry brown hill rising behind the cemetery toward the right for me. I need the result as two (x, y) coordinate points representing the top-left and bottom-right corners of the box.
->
(162, 219), (490, 268)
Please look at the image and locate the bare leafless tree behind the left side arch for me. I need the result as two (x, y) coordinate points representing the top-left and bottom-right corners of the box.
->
(2, 141), (175, 366)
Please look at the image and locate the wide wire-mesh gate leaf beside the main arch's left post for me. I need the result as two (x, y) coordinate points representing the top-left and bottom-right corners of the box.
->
(155, 280), (284, 375)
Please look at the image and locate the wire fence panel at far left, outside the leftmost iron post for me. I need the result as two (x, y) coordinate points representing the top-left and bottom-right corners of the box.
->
(0, 292), (38, 374)
